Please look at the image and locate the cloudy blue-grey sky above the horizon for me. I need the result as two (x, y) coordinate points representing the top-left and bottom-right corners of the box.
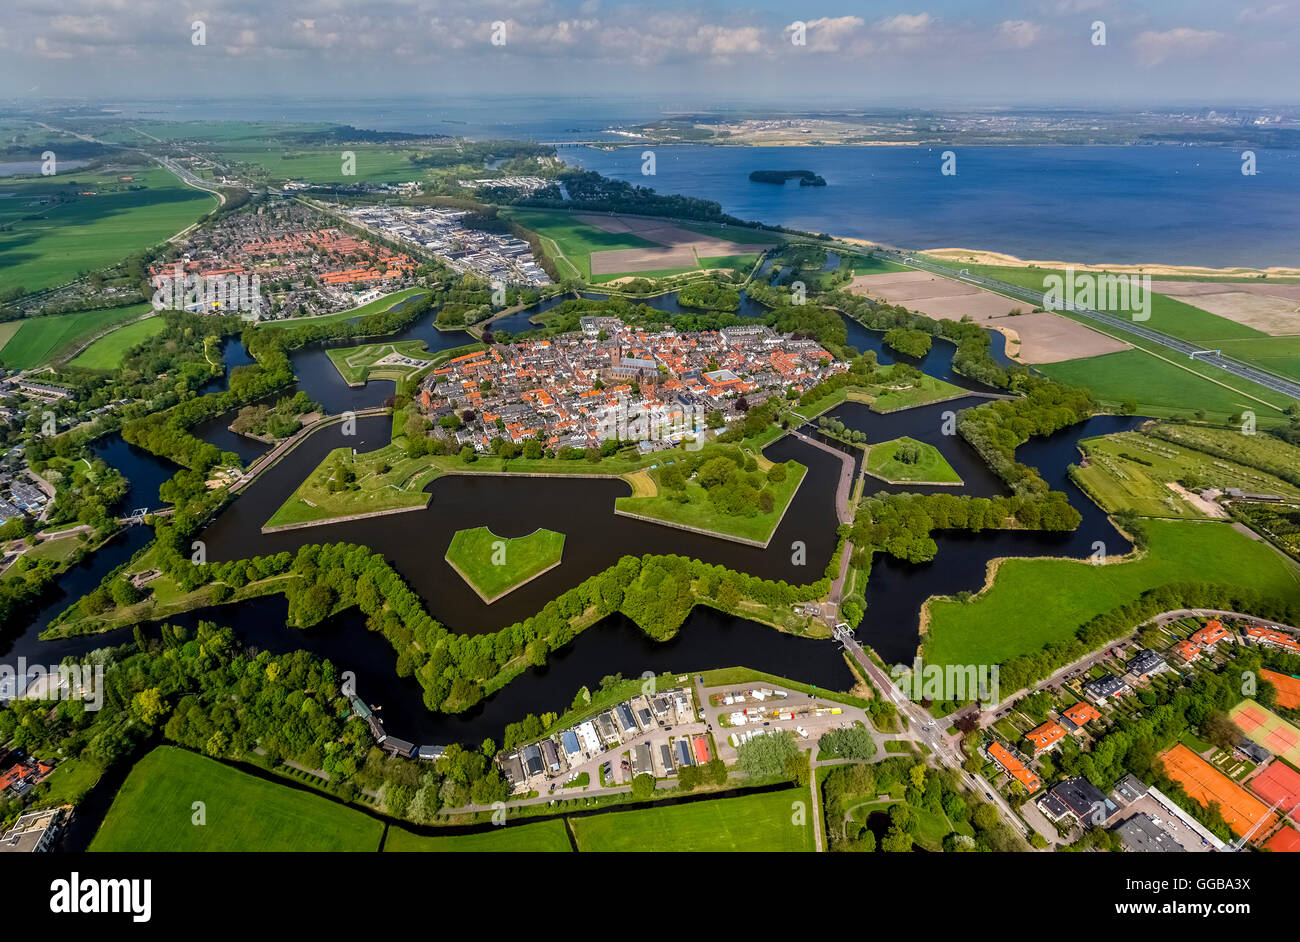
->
(0, 0), (1300, 109)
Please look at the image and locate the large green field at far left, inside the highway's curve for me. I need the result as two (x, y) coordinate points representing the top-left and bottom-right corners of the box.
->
(0, 168), (217, 294)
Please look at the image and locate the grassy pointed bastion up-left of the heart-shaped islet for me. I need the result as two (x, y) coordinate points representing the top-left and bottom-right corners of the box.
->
(264, 439), (441, 529)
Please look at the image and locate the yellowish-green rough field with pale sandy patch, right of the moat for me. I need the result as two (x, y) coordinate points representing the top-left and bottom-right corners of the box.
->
(1076, 426), (1300, 517)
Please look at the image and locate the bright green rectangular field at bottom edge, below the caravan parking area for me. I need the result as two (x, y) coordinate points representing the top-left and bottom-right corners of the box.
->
(569, 789), (814, 852)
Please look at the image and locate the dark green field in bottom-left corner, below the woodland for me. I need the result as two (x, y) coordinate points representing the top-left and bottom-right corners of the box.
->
(90, 746), (384, 851)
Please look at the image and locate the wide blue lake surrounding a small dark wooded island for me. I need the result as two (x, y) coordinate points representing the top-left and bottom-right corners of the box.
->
(560, 144), (1300, 266)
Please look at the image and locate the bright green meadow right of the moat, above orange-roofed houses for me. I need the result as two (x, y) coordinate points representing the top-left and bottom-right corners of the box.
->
(923, 520), (1300, 664)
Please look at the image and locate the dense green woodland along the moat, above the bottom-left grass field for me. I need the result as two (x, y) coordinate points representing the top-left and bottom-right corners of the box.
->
(0, 622), (508, 822)
